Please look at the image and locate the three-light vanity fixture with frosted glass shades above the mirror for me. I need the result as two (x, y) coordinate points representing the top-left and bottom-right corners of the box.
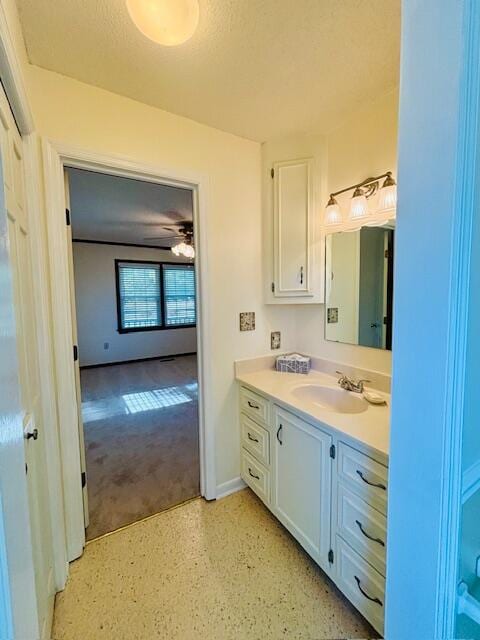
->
(325, 171), (397, 225)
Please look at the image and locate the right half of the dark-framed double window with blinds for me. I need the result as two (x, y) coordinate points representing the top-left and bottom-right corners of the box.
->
(163, 264), (196, 327)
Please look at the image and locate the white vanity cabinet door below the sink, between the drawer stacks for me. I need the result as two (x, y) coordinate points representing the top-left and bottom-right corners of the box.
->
(273, 407), (332, 569)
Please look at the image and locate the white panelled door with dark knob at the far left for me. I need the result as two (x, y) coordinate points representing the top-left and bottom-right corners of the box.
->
(0, 91), (55, 637)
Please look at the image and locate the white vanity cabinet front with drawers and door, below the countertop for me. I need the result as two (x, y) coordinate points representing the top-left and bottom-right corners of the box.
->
(240, 385), (388, 633)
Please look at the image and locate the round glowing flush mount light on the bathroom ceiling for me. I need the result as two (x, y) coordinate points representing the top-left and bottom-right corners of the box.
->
(127, 0), (200, 47)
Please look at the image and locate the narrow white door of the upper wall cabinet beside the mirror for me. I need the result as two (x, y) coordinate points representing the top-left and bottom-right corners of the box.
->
(273, 159), (313, 297)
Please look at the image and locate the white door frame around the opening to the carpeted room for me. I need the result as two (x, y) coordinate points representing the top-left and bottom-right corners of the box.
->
(43, 139), (216, 561)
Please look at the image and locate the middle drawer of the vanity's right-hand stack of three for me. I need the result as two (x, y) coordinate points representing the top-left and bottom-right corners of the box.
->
(337, 482), (387, 575)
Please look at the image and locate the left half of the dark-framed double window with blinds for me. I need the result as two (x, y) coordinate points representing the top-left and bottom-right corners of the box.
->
(118, 262), (162, 329)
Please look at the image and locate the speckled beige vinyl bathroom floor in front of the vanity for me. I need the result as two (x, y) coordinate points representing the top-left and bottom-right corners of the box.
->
(53, 489), (376, 640)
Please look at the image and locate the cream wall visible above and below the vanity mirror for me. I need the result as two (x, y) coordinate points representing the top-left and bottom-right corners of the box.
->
(296, 91), (398, 373)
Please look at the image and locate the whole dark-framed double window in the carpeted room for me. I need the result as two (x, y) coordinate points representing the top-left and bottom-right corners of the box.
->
(115, 260), (196, 333)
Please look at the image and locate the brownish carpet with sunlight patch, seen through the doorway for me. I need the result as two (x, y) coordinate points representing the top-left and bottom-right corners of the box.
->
(81, 356), (200, 540)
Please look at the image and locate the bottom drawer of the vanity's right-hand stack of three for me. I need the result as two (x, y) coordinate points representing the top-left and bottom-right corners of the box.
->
(335, 536), (385, 635)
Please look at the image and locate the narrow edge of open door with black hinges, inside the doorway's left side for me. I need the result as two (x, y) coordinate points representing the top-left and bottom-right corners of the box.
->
(63, 171), (90, 529)
